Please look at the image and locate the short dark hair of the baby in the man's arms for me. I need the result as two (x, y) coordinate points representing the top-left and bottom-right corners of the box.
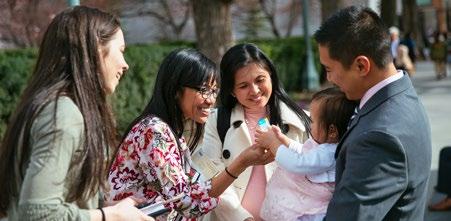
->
(312, 87), (357, 140)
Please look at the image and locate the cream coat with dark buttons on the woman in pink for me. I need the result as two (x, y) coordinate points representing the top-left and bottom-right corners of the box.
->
(193, 103), (307, 221)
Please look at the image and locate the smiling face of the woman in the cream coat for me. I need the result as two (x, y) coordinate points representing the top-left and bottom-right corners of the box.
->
(232, 63), (272, 109)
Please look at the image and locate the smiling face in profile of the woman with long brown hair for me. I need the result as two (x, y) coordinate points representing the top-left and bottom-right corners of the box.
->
(100, 29), (128, 94)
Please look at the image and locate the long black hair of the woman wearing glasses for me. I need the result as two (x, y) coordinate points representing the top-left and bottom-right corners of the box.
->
(127, 49), (219, 150)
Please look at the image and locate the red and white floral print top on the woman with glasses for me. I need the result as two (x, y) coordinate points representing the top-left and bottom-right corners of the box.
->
(104, 116), (218, 220)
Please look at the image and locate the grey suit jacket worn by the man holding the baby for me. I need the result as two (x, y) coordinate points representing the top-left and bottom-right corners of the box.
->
(325, 73), (431, 221)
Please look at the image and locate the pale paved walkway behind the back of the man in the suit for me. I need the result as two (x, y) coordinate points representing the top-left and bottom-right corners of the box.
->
(412, 62), (451, 221)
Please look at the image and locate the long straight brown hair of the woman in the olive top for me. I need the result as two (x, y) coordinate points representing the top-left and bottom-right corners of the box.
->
(0, 6), (120, 214)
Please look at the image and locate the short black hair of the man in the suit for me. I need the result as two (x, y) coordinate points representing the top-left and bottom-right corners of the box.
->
(314, 6), (393, 69)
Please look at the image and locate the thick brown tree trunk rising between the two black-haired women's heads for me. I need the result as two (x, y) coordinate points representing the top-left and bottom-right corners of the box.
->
(191, 0), (233, 64)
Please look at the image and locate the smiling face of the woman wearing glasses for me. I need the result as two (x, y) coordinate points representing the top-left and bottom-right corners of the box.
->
(180, 81), (217, 124)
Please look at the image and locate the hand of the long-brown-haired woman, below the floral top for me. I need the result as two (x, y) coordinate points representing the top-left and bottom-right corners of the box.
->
(103, 197), (154, 221)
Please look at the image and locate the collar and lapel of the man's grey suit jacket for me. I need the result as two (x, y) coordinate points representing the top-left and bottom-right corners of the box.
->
(335, 72), (413, 159)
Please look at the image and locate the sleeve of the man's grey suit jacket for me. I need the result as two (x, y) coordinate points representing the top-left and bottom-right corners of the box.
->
(325, 131), (407, 221)
